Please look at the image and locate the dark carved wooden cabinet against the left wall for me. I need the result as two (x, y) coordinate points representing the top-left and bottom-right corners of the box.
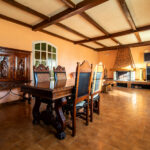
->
(0, 47), (31, 87)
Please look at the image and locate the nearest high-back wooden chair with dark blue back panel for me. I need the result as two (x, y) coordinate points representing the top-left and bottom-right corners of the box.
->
(72, 61), (93, 136)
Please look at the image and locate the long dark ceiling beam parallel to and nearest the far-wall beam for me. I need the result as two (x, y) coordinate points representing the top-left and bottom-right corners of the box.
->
(74, 25), (150, 44)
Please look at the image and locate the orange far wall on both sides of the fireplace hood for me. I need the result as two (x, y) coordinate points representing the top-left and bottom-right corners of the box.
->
(99, 46), (150, 80)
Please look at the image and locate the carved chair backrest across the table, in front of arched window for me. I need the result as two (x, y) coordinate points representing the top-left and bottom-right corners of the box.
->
(33, 64), (50, 84)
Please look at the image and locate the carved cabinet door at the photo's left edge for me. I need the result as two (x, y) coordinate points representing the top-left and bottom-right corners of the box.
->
(0, 54), (14, 81)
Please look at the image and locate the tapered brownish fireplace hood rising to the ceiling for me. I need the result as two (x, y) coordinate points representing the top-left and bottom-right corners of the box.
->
(111, 48), (136, 71)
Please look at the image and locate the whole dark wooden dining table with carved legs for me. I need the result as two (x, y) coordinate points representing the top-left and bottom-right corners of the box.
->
(21, 79), (75, 139)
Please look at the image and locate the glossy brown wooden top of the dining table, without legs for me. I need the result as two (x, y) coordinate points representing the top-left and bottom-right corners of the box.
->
(21, 79), (75, 100)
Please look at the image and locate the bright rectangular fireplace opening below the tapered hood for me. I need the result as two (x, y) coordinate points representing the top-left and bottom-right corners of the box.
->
(114, 71), (135, 81)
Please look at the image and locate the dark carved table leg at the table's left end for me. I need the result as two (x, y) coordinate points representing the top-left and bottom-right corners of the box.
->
(32, 97), (41, 124)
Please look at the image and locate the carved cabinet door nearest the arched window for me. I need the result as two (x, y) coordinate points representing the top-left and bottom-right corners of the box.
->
(15, 55), (30, 81)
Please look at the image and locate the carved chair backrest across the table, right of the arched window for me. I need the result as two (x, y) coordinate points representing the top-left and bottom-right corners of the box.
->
(53, 65), (67, 81)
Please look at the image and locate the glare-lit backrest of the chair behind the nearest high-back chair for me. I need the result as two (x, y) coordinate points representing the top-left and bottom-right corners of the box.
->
(92, 64), (103, 94)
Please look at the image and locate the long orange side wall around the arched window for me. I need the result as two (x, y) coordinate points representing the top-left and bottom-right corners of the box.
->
(0, 19), (99, 103)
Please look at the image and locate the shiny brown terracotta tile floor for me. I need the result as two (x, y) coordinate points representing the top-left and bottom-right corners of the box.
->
(0, 88), (150, 150)
